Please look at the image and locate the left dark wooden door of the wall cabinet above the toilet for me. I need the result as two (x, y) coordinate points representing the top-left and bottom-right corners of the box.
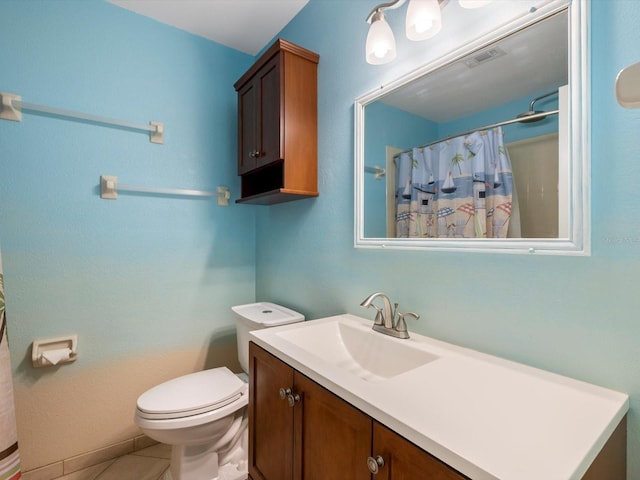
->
(238, 81), (260, 175)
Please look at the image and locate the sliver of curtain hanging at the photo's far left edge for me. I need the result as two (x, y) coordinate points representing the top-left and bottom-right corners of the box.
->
(0, 256), (22, 480)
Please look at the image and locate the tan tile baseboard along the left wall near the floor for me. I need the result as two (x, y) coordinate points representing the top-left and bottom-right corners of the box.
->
(23, 435), (158, 480)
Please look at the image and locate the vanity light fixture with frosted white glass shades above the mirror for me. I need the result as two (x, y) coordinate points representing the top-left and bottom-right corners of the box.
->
(366, 0), (492, 65)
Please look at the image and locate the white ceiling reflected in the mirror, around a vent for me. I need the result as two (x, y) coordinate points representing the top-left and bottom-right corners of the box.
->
(381, 13), (569, 123)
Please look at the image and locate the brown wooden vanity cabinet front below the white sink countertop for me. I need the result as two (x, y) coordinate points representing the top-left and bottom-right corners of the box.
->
(249, 343), (467, 480)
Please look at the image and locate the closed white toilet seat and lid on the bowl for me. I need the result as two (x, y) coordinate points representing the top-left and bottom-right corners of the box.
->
(136, 367), (247, 420)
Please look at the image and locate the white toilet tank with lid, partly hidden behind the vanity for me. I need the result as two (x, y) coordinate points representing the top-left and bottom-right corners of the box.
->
(231, 302), (304, 373)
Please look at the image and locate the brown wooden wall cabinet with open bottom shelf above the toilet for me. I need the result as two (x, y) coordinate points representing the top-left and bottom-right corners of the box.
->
(234, 39), (320, 205)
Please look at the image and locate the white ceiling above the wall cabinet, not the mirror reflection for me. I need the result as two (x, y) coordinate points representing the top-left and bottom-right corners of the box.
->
(107, 0), (309, 55)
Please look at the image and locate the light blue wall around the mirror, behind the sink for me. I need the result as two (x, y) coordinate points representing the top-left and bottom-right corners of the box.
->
(256, 0), (640, 479)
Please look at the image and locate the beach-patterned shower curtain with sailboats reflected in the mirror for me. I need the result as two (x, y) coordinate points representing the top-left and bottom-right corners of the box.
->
(395, 127), (513, 238)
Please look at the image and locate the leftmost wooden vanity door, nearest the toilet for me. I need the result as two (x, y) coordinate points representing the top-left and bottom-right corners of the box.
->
(249, 343), (294, 480)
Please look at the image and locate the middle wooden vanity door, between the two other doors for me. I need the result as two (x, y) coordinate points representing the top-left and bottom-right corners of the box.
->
(294, 372), (370, 480)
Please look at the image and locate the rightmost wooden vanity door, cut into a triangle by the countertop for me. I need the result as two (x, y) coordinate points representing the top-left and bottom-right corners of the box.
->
(372, 421), (468, 480)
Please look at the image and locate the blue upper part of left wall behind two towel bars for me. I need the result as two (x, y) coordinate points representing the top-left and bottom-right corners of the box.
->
(0, 0), (255, 368)
